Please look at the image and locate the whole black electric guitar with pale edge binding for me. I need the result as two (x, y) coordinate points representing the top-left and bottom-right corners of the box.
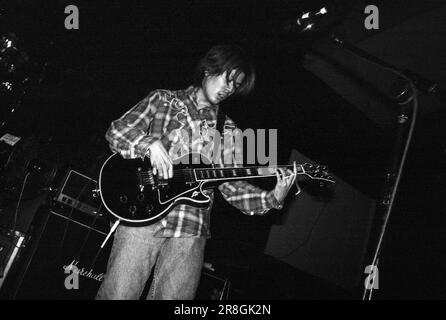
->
(99, 153), (334, 225)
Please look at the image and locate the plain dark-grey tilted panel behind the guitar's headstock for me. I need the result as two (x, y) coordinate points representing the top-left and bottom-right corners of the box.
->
(265, 150), (376, 293)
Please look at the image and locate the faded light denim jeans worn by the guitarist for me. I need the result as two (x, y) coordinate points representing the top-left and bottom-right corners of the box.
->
(96, 225), (206, 300)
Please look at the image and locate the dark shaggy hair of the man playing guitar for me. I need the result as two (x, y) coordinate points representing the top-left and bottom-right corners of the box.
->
(194, 45), (256, 95)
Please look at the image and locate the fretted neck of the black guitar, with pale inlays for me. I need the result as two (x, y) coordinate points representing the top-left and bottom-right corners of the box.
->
(193, 165), (304, 182)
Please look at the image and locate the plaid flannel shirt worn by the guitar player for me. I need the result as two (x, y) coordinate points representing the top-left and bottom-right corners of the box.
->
(106, 87), (282, 237)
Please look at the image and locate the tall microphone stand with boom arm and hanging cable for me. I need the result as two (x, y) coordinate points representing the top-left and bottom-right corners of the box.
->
(331, 34), (424, 300)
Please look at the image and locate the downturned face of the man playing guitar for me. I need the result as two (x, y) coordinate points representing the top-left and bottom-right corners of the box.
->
(203, 69), (245, 105)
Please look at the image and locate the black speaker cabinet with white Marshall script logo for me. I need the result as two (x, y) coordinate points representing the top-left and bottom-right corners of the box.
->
(2, 208), (113, 300)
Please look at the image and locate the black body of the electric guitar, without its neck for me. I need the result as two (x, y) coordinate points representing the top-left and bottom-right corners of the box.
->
(99, 153), (212, 225)
